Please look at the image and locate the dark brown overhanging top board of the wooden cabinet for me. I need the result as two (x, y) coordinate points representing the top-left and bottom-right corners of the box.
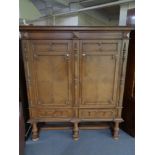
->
(19, 25), (134, 31)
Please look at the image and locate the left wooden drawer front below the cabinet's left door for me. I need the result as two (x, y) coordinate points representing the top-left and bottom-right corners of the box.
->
(31, 109), (73, 118)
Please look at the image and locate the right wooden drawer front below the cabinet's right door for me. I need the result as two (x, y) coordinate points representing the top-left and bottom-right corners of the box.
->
(79, 109), (115, 119)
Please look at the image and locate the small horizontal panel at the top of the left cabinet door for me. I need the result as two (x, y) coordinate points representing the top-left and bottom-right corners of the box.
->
(32, 40), (70, 52)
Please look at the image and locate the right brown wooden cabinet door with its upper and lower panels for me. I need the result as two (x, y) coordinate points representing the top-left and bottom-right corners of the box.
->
(80, 40), (121, 108)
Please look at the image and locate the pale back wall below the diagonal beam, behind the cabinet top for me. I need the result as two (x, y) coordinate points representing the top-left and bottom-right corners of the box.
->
(30, 10), (118, 26)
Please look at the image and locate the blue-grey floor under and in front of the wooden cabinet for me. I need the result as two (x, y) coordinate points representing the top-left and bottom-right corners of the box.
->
(25, 129), (135, 155)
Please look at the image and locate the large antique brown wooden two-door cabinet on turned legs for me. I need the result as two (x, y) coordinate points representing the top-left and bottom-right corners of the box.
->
(20, 26), (130, 140)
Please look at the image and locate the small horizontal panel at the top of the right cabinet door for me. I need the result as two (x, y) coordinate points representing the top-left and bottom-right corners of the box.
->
(82, 40), (120, 52)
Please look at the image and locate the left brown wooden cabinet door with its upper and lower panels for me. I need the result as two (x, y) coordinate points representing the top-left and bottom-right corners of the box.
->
(31, 40), (72, 107)
